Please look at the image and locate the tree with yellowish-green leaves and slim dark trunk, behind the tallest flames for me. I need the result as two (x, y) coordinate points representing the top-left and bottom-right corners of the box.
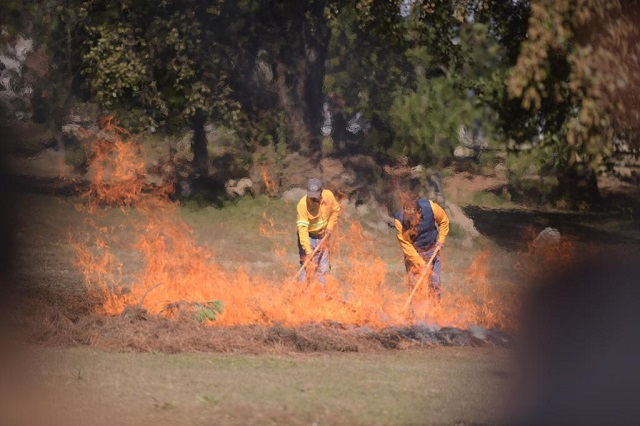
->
(81, 0), (239, 176)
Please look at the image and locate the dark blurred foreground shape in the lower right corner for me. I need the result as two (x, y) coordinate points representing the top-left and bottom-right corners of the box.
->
(507, 246), (640, 425)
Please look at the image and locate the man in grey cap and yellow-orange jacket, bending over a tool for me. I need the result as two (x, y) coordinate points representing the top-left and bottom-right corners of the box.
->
(296, 178), (340, 284)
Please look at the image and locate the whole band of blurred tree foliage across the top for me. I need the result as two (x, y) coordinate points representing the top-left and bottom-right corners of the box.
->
(0, 0), (640, 202)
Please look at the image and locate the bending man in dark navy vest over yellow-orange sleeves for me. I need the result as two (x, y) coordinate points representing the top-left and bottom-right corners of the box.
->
(394, 198), (449, 300)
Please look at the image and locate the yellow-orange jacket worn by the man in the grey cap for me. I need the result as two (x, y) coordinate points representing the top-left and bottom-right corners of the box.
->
(296, 189), (340, 254)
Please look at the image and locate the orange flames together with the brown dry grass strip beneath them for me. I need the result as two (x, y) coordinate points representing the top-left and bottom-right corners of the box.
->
(5, 117), (592, 353)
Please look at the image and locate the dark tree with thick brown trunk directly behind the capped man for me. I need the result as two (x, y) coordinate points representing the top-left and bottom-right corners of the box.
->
(224, 0), (329, 153)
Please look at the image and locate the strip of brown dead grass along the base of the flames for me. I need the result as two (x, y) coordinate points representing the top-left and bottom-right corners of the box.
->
(10, 289), (511, 355)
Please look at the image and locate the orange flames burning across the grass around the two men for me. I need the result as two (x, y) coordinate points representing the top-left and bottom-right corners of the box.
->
(71, 121), (515, 328)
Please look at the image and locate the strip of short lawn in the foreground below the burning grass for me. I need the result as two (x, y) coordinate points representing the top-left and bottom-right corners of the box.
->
(0, 348), (509, 425)
